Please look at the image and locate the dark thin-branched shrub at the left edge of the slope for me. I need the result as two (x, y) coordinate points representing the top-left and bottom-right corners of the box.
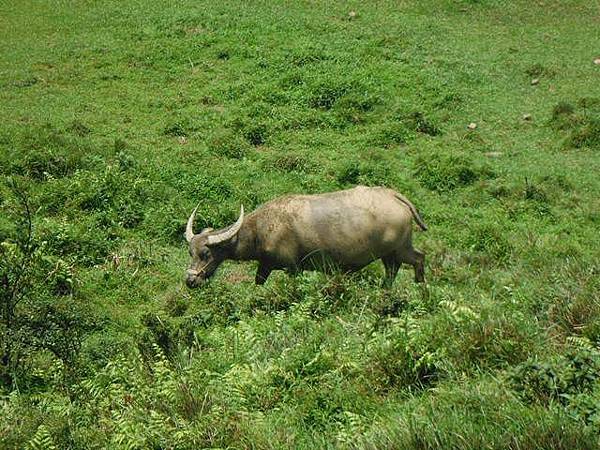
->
(0, 179), (96, 389)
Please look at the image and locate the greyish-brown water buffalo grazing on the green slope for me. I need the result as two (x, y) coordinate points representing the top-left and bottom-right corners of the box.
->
(185, 186), (427, 288)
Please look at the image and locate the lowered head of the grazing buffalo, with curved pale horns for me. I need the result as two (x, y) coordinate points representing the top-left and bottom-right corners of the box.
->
(185, 205), (244, 288)
